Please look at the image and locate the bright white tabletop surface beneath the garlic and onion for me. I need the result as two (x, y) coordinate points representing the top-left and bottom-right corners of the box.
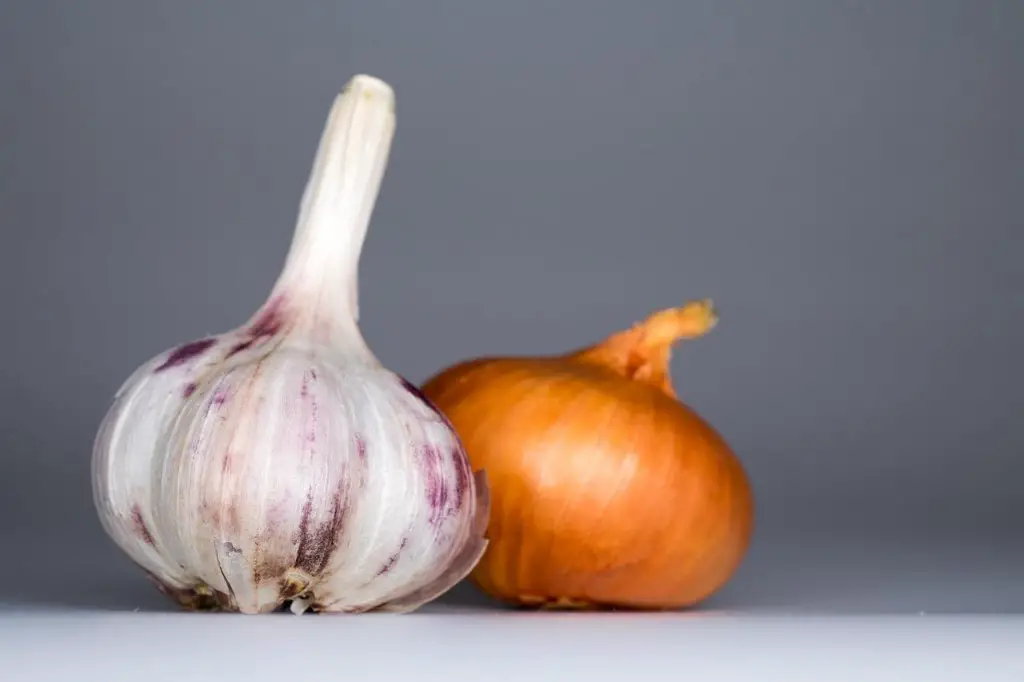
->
(0, 606), (1024, 682)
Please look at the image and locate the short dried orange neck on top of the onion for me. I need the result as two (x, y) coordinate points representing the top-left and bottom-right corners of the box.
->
(570, 300), (718, 397)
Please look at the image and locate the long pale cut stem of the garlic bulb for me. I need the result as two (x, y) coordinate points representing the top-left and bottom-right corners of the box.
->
(260, 75), (395, 352)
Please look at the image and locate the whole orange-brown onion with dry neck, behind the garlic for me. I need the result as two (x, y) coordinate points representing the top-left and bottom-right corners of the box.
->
(423, 301), (754, 609)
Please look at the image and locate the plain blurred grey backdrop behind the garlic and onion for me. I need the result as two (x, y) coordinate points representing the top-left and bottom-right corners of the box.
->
(0, 0), (1024, 611)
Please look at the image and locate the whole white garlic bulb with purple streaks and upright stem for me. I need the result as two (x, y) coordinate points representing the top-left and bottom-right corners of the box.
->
(93, 76), (488, 613)
